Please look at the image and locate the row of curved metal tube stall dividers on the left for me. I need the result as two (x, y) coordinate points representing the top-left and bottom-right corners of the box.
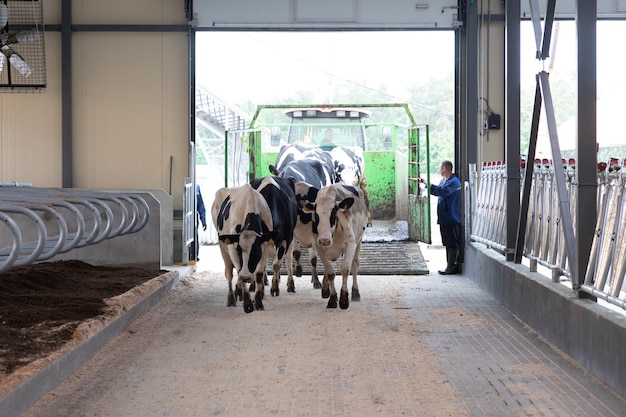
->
(0, 183), (150, 272)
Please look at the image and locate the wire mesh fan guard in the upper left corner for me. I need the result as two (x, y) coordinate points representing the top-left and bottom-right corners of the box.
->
(0, 0), (47, 92)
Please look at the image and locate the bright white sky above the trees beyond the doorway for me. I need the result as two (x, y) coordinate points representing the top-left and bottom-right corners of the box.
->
(196, 31), (454, 103)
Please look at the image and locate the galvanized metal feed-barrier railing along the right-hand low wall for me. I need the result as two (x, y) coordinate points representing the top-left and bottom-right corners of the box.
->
(466, 159), (626, 309)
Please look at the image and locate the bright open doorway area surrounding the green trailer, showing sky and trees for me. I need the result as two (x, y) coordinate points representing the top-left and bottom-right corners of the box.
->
(196, 30), (454, 250)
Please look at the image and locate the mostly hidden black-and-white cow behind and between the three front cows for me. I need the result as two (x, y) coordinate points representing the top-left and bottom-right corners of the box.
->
(269, 144), (336, 289)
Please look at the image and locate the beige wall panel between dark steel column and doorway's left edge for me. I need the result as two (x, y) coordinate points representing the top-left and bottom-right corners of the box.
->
(73, 33), (188, 196)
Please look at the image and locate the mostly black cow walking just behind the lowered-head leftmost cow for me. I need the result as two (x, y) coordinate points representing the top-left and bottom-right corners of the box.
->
(250, 176), (297, 296)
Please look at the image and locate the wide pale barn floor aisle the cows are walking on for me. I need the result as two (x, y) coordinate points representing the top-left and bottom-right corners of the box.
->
(19, 246), (626, 417)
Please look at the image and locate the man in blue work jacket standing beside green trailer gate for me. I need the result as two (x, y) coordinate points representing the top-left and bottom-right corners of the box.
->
(420, 161), (461, 275)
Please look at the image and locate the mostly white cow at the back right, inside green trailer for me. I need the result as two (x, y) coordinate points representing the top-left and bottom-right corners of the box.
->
(330, 146), (372, 227)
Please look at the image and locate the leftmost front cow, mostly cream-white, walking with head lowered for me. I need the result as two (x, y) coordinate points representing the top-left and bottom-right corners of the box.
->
(211, 184), (276, 313)
